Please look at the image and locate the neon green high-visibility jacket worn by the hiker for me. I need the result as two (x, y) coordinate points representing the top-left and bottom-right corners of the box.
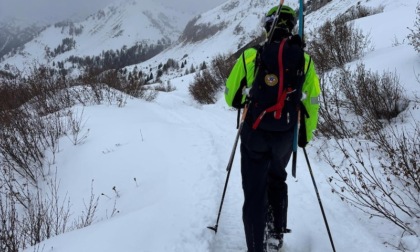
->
(225, 48), (321, 142)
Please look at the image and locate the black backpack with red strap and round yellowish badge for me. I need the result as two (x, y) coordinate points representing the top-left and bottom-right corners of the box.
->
(225, 35), (305, 131)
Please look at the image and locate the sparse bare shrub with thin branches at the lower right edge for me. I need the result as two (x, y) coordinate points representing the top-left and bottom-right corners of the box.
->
(320, 121), (420, 235)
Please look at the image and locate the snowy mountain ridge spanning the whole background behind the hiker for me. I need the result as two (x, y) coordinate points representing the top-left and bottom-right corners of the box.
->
(0, 0), (415, 79)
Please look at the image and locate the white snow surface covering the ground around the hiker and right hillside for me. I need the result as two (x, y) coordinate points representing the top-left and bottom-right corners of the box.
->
(9, 0), (420, 252)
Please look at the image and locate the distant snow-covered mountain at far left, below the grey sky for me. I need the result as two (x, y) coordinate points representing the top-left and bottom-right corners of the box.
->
(0, 0), (186, 70)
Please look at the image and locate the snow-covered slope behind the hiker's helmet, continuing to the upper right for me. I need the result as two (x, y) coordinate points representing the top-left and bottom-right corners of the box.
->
(128, 0), (416, 85)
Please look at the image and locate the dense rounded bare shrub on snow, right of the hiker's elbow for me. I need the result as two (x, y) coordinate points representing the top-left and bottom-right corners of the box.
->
(319, 64), (409, 138)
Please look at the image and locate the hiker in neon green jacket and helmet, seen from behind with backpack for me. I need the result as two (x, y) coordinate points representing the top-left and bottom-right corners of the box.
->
(225, 5), (320, 252)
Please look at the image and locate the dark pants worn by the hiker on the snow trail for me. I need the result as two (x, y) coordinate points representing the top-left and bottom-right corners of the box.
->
(241, 122), (294, 252)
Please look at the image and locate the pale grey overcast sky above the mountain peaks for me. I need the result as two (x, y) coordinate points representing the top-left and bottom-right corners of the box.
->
(0, 0), (228, 25)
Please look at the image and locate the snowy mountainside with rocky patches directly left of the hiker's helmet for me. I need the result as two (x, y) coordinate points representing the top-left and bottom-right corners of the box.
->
(128, 0), (298, 78)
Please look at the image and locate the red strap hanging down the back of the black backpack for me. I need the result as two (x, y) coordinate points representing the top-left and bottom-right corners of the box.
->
(252, 39), (292, 130)
